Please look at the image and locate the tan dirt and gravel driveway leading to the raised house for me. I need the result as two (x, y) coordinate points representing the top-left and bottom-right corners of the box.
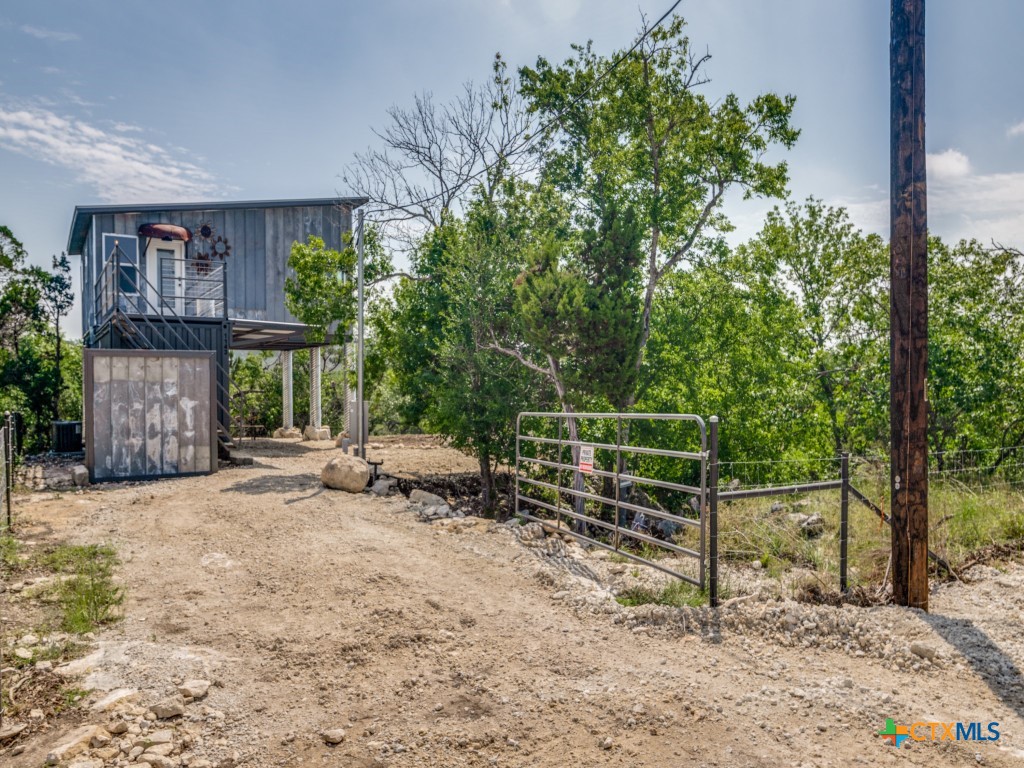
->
(9, 441), (1024, 767)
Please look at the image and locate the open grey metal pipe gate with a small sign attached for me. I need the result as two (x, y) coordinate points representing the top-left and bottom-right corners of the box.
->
(515, 412), (718, 605)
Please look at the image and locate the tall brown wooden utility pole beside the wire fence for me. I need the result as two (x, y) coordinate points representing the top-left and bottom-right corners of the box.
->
(889, 0), (928, 610)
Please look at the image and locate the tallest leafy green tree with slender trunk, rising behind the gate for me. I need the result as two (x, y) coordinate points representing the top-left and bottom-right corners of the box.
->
(520, 16), (799, 408)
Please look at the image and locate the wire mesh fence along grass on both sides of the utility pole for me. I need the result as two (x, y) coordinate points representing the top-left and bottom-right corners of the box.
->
(719, 446), (1024, 587)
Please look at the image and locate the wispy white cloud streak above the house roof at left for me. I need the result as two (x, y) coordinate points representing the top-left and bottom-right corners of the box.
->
(0, 106), (225, 203)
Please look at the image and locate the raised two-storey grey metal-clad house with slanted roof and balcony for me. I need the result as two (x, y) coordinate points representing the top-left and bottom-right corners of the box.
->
(68, 198), (366, 480)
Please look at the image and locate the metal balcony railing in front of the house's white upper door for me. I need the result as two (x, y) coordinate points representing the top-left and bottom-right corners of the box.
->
(94, 249), (227, 323)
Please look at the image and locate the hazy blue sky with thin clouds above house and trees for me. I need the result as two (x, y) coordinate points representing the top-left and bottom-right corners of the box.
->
(0, 0), (1024, 335)
